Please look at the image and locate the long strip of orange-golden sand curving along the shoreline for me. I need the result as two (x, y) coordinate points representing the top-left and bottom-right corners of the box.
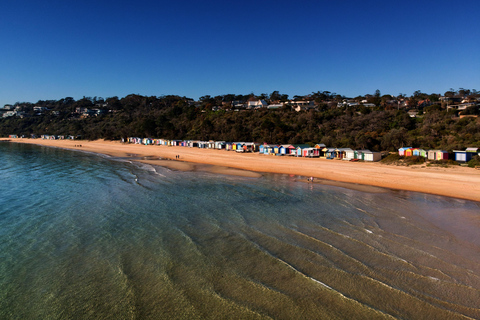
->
(0, 138), (480, 201)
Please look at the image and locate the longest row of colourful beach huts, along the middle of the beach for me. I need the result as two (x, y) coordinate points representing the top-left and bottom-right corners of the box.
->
(124, 137), (382, 161)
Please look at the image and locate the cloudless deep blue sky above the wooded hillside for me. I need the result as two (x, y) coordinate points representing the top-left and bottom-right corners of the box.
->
(0, 0), (480, 105)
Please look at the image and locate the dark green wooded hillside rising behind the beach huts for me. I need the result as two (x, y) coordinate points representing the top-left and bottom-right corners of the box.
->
(0, 92), (480, 151)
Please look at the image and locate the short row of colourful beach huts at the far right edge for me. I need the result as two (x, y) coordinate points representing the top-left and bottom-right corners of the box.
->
(398, 147), (480, 163)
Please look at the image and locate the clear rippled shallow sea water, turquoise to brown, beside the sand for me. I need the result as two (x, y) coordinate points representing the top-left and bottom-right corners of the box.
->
(0, 143), (480, 319)
